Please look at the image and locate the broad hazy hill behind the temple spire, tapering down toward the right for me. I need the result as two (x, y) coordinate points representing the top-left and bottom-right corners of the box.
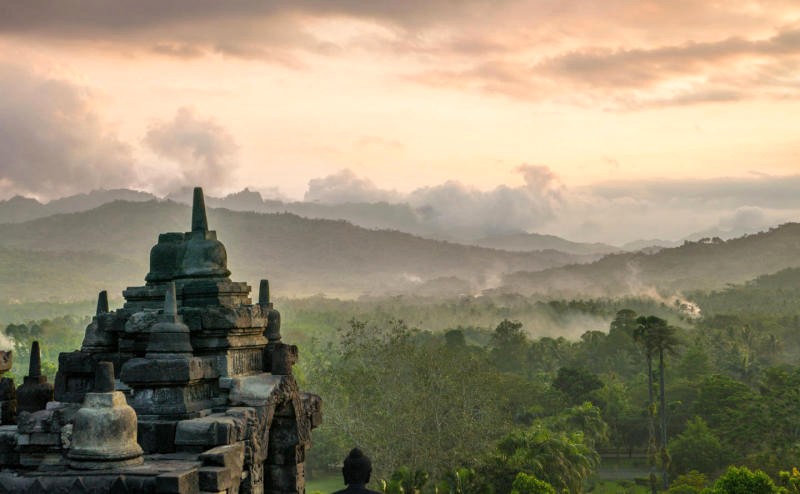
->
(0, 201), (593, 302)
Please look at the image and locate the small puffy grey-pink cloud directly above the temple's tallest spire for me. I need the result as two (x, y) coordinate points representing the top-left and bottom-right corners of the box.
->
(143, 107), (238, 191)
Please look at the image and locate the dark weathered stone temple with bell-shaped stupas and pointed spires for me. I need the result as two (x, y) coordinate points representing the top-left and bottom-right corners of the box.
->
(0, 188), (322, 494)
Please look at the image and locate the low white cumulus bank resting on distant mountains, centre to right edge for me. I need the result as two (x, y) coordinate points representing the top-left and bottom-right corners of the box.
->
(306, 169), (800, 245)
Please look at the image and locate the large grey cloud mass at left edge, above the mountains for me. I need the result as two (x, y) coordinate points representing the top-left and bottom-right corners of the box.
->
(0, 65), (137, 198)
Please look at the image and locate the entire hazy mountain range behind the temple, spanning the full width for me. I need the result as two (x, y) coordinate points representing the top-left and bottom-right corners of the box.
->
(0, 190), (800, 303)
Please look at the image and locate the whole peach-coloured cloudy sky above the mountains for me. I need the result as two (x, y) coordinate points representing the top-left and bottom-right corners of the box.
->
(0, 0), (800, 243)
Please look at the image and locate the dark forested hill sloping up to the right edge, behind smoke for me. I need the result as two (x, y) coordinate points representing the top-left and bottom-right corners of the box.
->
(501, 223), (800, 296)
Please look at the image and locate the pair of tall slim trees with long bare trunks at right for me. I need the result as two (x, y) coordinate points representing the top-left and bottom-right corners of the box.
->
(633, 316), (679, 493)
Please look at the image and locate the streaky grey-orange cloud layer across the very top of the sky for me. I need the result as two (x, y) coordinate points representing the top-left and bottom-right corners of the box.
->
(0, 0), (800, 111)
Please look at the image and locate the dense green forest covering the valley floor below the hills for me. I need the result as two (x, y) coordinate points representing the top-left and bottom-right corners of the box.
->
(2, 269), (800, 493)
